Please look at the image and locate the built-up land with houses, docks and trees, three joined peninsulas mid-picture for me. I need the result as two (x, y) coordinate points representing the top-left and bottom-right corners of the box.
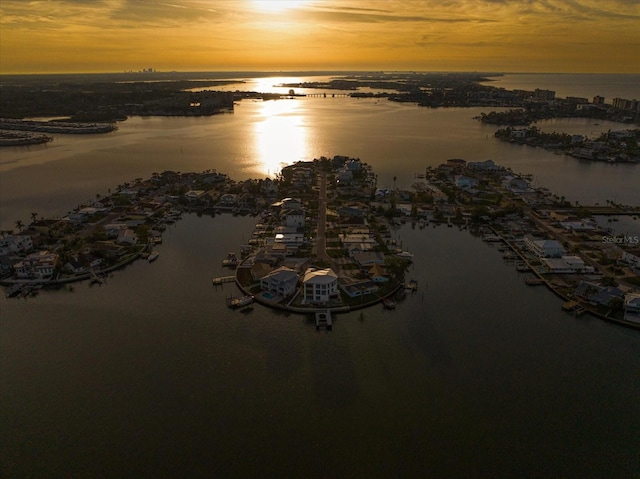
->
(0, 156), (640, 327)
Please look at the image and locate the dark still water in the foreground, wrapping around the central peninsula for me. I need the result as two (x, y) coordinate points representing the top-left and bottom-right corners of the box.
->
(0, 215), (640, 478)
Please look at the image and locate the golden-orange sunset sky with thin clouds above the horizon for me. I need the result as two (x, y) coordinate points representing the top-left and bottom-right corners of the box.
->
(0, 0), (640, 73)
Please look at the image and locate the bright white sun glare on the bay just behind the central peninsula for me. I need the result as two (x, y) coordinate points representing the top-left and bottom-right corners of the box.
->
(254, 100), (307, 176)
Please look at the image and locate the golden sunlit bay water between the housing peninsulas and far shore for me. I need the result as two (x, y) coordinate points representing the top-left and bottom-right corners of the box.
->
(0, 98), (640, 229)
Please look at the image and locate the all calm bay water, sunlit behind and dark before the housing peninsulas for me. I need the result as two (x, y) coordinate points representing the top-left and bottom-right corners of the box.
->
(0, 74), (640, 478)
